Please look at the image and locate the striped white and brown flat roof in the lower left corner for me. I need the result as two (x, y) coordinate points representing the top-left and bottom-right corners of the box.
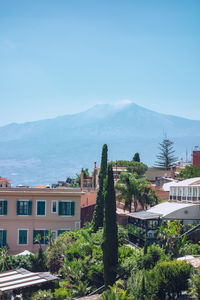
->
(0, 268), (58, 295)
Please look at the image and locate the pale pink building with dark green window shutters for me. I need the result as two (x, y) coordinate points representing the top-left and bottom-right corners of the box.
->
(0, 188), (84, 254)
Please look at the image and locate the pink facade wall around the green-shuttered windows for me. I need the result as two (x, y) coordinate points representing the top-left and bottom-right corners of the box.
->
(0, 189), (83, 254)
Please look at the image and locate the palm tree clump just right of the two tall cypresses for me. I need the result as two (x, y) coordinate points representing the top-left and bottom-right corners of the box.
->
(115, 172), (158, 212)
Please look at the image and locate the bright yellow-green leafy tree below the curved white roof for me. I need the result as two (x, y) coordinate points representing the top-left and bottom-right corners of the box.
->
(158, 220), (184, 257)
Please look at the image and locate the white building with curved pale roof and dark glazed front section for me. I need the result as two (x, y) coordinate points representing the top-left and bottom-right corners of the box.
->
(128, 177), (200, 245)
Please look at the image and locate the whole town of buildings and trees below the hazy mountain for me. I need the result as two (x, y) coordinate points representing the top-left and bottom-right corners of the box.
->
(0, 141), (200, 299)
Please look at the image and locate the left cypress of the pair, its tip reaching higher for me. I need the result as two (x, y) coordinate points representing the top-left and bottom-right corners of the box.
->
(92, 144), (108, 232)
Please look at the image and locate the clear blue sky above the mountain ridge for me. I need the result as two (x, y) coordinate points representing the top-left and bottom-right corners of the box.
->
(0, 0), (200, 126)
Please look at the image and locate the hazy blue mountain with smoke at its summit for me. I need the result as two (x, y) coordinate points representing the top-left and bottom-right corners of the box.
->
(0, 103), (200, 185)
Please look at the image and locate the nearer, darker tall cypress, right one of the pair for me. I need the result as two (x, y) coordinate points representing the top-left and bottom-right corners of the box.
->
(102, 165), (118, 287)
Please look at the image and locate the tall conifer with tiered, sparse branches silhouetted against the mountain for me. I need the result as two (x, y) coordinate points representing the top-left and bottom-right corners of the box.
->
(156, 138), (177, 170)
